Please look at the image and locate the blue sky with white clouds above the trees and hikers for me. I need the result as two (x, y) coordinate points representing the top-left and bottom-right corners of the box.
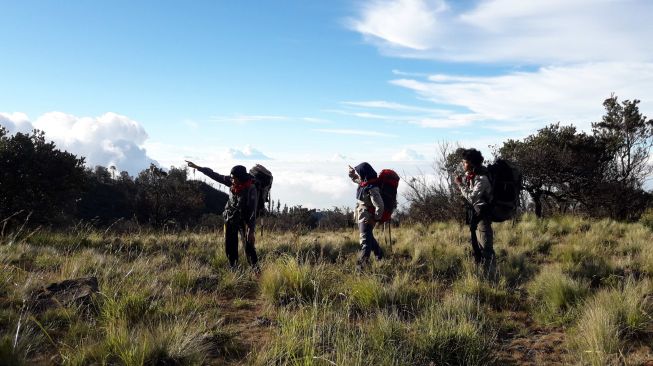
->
(0, 0), (653, 208)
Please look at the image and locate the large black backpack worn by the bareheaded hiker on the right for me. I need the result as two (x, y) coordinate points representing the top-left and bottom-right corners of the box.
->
(487, 159), (522, 222)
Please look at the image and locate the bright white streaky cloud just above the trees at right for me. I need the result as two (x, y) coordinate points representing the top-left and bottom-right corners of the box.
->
(392, 62), (653, 131)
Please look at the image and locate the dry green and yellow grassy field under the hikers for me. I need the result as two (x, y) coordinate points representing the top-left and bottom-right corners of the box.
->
(0, 216), (653, 365)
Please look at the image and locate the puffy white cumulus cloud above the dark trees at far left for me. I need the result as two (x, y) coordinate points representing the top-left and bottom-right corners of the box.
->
(0, 112), (155, 174)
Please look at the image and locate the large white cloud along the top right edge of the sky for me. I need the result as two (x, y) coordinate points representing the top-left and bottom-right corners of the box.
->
(349, 0), (653, 63)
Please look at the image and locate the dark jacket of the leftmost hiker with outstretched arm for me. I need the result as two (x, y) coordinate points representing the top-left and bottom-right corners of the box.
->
(197, 168), (258, 230)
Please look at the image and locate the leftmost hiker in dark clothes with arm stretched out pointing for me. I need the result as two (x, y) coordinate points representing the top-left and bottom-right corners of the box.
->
(186, 160), (258, 269)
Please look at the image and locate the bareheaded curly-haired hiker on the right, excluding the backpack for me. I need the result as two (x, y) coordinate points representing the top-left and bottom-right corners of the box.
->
(455, 149), (494, 269)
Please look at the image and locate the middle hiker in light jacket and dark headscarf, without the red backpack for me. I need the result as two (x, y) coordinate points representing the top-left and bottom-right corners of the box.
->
(349, 163), (384, 270)
